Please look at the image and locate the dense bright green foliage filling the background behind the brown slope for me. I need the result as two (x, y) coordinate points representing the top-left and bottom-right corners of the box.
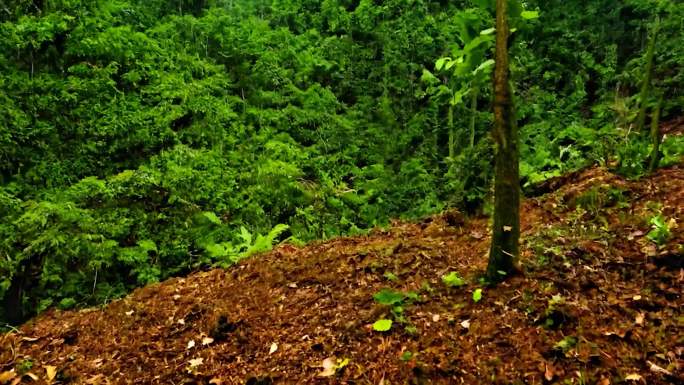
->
(0, 0), (684, 319)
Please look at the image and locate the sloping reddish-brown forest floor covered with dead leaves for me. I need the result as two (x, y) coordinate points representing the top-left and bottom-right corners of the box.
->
(0, 167), (684, 385)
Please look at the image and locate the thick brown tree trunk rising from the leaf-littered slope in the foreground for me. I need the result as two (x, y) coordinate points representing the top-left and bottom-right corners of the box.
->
(487, 0), (520, 283)
